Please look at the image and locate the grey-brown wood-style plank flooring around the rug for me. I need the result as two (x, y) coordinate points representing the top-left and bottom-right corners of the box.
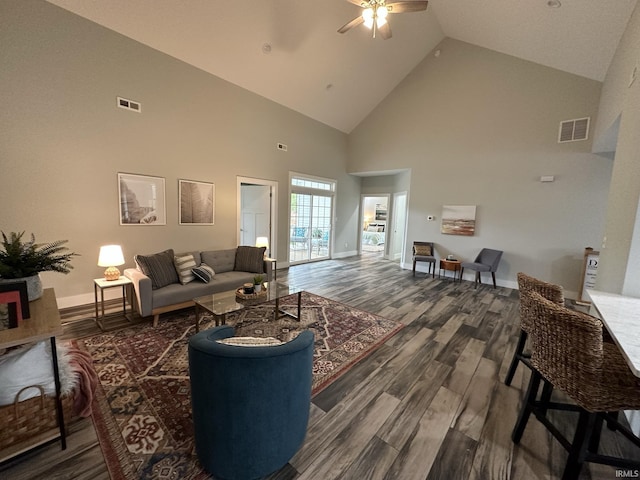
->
(0, 254), (638, 480)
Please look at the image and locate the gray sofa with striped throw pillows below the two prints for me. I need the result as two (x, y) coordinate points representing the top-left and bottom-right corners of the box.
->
(124, 247), (273, 326)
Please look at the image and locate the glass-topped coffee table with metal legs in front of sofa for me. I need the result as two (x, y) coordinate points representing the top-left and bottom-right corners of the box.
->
(193, 281), (302, 332)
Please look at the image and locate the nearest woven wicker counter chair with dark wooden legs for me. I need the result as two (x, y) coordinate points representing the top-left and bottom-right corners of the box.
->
(512, 292), (640, 480)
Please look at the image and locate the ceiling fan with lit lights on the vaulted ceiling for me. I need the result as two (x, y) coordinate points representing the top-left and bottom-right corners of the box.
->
(338, 0), (429, 40)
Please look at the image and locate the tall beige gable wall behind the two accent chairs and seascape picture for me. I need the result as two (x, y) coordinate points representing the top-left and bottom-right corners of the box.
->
(348, 39), (611, 292)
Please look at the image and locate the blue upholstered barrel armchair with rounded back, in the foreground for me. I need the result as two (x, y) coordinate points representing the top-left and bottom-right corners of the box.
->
(189, 325), (314, 480)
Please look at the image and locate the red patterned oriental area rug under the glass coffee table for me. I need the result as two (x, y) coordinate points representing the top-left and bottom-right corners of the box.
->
(78, 292), (403, 480)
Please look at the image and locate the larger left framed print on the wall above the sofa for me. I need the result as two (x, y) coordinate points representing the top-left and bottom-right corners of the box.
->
(118, 173), (167, 225)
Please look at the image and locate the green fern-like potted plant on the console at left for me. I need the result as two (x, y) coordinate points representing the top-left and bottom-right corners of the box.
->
(0, 232), (78, 301)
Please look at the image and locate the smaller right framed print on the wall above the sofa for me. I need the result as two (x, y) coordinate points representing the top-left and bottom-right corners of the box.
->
(178, 180), (215, 225)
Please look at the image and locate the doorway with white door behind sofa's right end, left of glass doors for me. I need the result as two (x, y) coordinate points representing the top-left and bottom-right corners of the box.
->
(237, 177), (278, 258)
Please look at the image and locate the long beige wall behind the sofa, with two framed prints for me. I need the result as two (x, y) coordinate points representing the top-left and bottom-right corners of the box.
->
(0, 0), (360, 305)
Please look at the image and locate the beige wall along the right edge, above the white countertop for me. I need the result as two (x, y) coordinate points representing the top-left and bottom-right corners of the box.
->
(595, 4), (640, 297)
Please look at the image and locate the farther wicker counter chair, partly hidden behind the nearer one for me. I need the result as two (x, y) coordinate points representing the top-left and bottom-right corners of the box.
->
(504, 272), (564, 385)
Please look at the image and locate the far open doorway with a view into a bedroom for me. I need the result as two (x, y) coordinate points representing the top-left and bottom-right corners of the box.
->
(360, 194), (390, 258)
